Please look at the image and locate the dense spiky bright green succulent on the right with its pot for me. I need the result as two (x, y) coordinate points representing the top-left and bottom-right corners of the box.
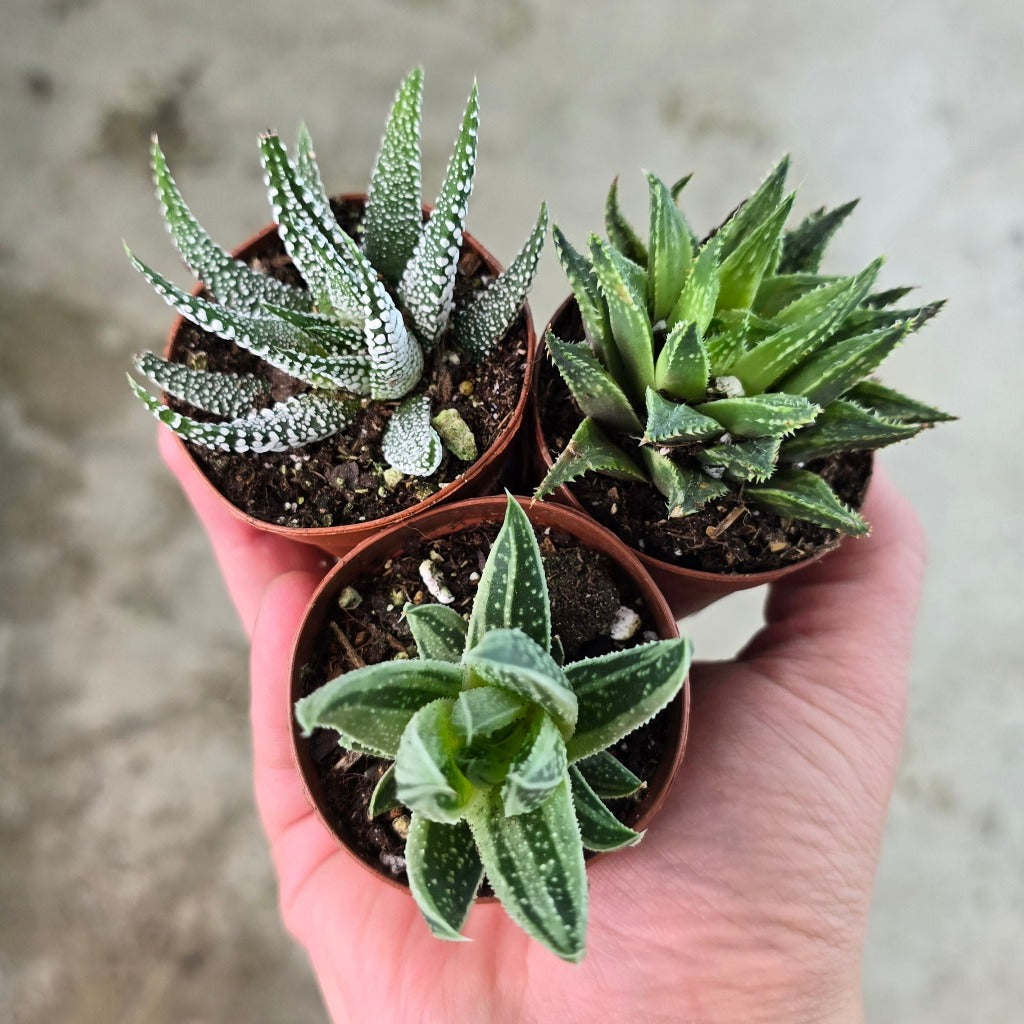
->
(534, 159), (951, 613)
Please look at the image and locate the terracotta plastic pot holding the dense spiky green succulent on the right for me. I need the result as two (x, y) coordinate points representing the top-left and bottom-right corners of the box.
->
(529, 296), (868, 618)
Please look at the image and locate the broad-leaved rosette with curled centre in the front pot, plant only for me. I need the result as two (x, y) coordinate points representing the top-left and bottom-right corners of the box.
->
(295, 497), (690, 962)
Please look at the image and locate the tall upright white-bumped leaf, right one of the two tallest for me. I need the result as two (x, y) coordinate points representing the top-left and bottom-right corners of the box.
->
(398, 83), (480, 351)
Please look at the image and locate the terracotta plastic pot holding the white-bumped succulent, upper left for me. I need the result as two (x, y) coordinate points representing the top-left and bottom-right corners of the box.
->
(164, 194), (537, 556)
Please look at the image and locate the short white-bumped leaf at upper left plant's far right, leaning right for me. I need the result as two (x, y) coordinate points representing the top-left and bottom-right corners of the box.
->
(454, 203), (548, 359)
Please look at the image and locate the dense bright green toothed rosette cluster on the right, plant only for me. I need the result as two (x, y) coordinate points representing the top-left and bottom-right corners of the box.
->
(537, 158), (952, 535)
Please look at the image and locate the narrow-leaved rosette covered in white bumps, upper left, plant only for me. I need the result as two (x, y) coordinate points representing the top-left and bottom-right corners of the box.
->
(129, 69), (547, 476)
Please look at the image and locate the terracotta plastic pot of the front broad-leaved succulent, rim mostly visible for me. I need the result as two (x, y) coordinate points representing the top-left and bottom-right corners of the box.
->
(289, 497), (690, 899)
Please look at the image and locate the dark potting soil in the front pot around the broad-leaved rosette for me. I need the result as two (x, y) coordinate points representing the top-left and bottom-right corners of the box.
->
(302, 523), (671, 895)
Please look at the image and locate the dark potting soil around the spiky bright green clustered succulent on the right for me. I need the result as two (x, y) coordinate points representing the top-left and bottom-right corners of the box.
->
(537, 305), (871, 573)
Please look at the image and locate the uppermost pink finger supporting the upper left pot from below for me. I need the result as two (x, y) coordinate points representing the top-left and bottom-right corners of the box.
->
(158, 426), (330, 636)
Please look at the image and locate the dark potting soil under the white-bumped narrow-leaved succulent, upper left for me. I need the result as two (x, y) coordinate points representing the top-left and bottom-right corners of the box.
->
(169, 197), (527, 527)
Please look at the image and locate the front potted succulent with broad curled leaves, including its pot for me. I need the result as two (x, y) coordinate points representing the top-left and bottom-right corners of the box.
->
(292, 496), (690, 961)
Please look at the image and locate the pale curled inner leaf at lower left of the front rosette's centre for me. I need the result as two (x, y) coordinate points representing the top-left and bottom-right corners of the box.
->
(394, 699), (474, 824)
